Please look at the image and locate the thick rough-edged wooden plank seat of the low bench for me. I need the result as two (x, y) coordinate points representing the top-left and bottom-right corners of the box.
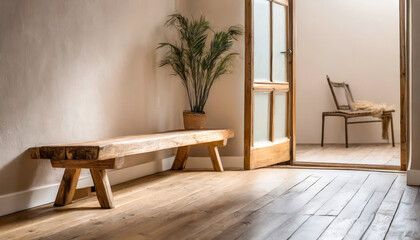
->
(31, 129), (234, 160)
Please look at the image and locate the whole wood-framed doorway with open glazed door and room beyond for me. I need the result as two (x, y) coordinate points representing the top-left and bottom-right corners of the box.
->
(244, 0), (407, 170)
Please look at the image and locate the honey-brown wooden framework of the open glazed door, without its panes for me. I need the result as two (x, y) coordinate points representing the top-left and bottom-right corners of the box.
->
(244, 0), (296, 170)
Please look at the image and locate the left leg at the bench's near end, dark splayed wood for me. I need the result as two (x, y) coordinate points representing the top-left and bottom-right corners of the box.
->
(54, 168), (81, 206)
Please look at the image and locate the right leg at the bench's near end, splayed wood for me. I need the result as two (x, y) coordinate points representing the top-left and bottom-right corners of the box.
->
(90, 169), (114, 208)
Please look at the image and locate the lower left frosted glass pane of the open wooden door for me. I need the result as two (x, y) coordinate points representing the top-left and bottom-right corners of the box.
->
(254, 92), (270, 143)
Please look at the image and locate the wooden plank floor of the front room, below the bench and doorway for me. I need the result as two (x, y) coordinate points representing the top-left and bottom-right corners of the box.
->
(0, 168), (420, 240)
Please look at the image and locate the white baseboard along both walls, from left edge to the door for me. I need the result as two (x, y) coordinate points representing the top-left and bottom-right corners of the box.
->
(0, 157), (244, 216)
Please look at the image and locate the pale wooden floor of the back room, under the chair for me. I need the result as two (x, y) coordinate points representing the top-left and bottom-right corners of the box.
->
(296, 144), (401, 166)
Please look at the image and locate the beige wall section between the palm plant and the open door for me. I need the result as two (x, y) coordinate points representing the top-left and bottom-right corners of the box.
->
(179, 0), (245, 156)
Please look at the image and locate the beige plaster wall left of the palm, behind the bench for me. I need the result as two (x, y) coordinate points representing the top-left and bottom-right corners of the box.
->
(0, 0), (185, 197)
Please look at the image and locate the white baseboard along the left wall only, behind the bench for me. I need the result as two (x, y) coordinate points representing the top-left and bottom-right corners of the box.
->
(0, 157), (174, 216)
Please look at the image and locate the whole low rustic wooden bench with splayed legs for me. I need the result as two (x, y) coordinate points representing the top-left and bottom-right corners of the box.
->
(31, 129), (234, 208)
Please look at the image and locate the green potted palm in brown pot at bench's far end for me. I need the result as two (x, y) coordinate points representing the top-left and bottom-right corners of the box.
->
(158, 14), (243, 129)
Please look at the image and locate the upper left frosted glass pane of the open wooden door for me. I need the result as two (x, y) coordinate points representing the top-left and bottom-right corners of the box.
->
(254, 0), (270, 82)
